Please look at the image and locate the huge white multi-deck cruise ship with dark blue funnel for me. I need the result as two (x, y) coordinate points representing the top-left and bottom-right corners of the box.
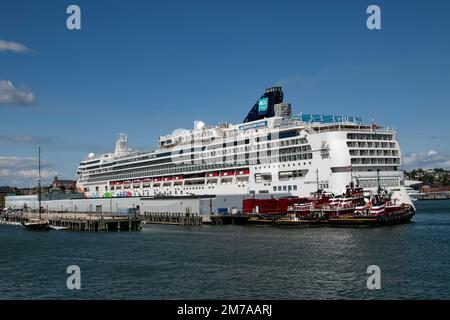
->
(77, 87), (412, 205)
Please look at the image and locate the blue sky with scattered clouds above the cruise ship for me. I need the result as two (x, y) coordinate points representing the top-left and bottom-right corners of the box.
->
(0, 0), (450, 187)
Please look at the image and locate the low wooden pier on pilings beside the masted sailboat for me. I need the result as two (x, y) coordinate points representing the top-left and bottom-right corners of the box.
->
(3, 212), (141, 232)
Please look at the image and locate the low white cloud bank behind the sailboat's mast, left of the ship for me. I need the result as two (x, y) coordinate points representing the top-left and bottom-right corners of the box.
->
(0, 157), (58, 186)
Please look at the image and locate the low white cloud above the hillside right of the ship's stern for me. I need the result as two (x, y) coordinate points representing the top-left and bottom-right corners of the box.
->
(403, 150), (450, 169)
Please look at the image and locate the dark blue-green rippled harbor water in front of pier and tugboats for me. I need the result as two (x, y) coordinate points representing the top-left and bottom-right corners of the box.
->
(0, 201), (450, 299)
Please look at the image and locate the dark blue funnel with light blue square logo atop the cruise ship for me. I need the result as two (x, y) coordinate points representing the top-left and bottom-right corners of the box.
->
(244, 87), (283, 122)
